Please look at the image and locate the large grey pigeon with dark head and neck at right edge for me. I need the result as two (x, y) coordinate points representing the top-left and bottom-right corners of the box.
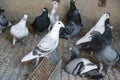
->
(90, 31), (120, 73)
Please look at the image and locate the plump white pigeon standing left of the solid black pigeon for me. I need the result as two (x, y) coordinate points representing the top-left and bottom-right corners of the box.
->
(10, 15), (29, 46)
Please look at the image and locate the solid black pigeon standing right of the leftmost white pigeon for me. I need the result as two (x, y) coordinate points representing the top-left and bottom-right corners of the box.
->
(32, 8), (50, 36)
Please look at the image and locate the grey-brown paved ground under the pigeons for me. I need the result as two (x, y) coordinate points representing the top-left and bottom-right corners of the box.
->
(0, 20), (120, 80)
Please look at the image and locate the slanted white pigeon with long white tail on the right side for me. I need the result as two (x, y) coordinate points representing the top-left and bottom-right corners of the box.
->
(75, 12), (112, 45)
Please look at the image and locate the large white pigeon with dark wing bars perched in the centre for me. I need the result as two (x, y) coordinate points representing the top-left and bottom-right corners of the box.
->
(21, 21), (65, 63)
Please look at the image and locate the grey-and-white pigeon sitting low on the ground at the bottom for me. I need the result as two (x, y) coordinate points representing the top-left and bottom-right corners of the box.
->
(66, 47), (103, 79)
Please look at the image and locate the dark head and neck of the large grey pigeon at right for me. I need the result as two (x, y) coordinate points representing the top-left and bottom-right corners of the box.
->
(90, 31), (108, 51)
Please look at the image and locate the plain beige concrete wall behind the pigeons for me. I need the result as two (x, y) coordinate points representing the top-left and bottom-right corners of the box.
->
(0, 0), (120, 27)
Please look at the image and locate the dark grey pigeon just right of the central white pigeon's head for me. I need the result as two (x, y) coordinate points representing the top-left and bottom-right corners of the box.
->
(60, 10), (83, 39)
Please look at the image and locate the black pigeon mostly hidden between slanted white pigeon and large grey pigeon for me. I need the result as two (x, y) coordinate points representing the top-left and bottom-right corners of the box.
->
(81, 19), (112, 50)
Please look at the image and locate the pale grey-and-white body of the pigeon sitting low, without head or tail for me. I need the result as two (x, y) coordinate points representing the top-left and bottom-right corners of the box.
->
(66, 58), (98, 75)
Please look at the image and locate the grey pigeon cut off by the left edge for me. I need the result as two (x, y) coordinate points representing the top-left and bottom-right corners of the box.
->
(0, 7), (12, 33)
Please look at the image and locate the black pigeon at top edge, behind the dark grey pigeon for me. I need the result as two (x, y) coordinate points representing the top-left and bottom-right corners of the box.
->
(66, 0), (77, 20)
